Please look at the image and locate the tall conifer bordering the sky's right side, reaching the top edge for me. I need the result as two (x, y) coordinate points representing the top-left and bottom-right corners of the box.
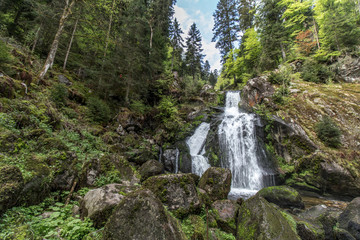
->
(212, 0), (240, 62)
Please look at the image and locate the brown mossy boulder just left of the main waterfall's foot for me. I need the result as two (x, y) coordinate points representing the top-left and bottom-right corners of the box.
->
(198, 167), (231, 201)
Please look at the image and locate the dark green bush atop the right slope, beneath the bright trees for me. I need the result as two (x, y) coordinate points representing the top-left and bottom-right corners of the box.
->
(301, 59), (334, 83)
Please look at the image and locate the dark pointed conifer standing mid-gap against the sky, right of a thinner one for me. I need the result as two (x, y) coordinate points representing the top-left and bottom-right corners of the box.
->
(185, 23), (204, 80)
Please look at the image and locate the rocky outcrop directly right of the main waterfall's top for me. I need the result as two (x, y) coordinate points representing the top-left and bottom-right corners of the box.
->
(241, 77), (275, 108)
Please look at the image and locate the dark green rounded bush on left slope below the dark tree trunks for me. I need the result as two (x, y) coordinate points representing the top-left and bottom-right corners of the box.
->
(87, 97), (110, 123)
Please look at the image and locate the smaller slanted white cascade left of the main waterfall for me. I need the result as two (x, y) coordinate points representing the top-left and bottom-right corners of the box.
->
(186, 123), (210, 176)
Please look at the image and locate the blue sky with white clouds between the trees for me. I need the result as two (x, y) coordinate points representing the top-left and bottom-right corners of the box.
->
(174, 0), (221, 71)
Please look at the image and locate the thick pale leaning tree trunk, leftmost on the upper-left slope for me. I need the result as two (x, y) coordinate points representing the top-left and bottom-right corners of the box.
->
(39, 0), (76, 81)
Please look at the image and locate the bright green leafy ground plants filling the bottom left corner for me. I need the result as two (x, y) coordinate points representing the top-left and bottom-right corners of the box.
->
(0, 198), (95, 240)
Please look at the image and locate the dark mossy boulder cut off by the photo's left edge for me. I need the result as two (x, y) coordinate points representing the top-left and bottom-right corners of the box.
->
(0, 165), (24, 215)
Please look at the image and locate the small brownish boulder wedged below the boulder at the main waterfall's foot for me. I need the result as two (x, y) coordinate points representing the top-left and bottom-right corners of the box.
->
(212, 200), (240, 235)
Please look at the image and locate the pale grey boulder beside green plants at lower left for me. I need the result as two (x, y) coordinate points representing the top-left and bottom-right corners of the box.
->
(80, 184), (136, 227)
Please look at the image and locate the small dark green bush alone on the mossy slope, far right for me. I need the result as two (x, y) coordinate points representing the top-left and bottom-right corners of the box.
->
(316, 116), (341, 148)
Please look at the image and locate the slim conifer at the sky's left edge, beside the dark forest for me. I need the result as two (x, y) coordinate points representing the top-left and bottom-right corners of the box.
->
(170, 18), (184, 69)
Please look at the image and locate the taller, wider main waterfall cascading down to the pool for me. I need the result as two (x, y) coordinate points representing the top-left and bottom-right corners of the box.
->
(218, 92), (264, 198)
